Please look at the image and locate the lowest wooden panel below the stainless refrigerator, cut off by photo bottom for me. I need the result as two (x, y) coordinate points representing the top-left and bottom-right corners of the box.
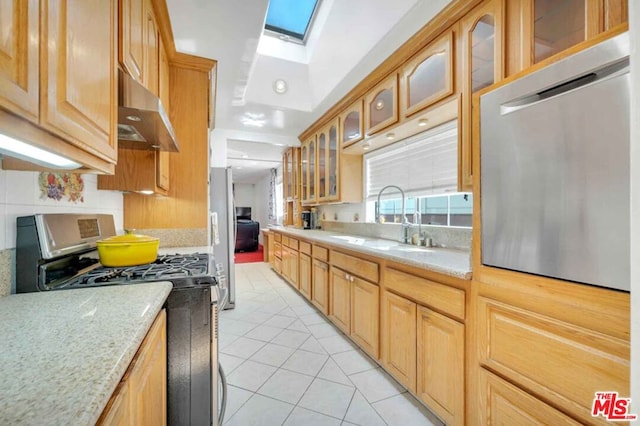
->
(478, 368), (581, 426)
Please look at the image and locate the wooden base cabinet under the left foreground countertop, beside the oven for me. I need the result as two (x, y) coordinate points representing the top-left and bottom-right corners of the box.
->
(98, 310), (167, 425)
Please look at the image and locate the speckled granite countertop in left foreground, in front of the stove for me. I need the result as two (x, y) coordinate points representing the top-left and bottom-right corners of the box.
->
(0, 282), (172, 425)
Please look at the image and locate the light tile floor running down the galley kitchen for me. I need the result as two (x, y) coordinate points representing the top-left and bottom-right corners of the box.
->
(219, 263), (442, 426)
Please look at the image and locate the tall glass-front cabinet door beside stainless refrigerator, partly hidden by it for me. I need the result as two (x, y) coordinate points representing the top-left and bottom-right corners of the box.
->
(458, 0), (504, 191)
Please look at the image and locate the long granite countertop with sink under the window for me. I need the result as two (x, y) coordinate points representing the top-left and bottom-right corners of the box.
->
(271, 227), (471, 280)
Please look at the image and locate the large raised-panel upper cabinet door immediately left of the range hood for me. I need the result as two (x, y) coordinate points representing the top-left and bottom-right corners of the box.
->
(40, 0), (118, 162)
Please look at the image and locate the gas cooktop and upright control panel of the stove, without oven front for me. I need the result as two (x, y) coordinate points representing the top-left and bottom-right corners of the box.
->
(16, 214), (224, 293)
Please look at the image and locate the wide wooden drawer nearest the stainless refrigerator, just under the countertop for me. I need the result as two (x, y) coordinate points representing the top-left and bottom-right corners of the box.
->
(384, 268), (465, 320)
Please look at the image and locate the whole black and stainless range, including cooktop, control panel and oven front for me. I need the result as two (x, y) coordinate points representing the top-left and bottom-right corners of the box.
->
(16, 214), (227, 425)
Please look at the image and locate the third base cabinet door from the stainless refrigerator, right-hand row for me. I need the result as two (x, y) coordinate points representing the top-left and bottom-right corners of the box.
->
(351, 277), (380, 359)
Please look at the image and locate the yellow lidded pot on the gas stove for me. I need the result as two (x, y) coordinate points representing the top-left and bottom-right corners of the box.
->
(96, 233), (160, 267)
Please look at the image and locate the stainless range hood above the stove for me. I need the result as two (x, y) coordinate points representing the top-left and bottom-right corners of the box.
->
(118, 69), (179, 152)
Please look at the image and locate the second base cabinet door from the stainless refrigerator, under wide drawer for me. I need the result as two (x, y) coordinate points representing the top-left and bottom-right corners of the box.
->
(381, 291), (417, 392)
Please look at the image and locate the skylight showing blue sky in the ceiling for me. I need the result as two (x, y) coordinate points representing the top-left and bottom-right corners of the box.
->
(264, 0), (319, 43)
